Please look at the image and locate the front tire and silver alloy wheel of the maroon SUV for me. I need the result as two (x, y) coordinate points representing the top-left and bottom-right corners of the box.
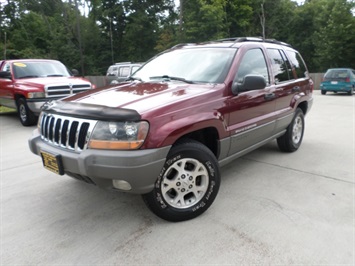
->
(142, 139), (220, 222)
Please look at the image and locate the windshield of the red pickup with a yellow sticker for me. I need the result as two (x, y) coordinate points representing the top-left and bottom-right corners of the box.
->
(12, 61), (71, 79)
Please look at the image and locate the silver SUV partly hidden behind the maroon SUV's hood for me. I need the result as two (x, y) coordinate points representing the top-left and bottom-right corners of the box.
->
(106, 62), (142, 84)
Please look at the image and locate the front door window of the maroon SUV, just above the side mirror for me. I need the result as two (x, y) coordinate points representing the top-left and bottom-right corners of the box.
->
(236, 49), (270, 84)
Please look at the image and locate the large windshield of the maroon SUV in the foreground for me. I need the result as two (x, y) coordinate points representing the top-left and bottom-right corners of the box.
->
(132, 48), (237, 83)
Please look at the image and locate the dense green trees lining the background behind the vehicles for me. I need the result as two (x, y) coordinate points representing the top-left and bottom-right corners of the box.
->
(0, 0), (355, 75)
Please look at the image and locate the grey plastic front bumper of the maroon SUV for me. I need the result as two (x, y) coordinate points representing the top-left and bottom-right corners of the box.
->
(28, 130), (170, 194)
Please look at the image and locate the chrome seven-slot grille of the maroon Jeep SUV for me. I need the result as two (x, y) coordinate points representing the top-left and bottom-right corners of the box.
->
(40, 112), (97, 152)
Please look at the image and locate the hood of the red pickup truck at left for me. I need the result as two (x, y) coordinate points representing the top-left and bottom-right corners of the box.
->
(16, 77), (90, 87)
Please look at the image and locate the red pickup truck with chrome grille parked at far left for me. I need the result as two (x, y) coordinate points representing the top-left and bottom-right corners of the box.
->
(0, 59), (94, 126)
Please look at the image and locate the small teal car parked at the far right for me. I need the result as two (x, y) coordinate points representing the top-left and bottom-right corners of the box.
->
(320, 68), (355, 95)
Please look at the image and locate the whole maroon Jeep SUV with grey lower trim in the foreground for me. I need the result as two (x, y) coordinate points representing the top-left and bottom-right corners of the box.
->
(29, 38), (313, 221)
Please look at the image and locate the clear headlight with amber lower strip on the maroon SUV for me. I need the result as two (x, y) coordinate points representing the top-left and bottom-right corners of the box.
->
(88, 121), (149, 150)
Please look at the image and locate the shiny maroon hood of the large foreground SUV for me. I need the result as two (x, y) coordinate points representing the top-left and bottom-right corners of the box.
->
(64, 82), (218, 114)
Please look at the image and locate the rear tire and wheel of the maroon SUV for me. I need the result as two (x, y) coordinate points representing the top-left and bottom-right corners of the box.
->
(277, 108), (305, 152)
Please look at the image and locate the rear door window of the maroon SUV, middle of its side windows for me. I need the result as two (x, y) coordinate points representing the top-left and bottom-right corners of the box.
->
(267, 49), (293, 83)
